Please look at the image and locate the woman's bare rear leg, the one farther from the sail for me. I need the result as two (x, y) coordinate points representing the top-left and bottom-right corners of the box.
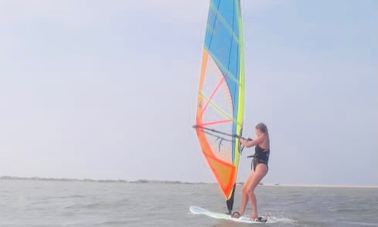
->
(247, 164), (268, 220)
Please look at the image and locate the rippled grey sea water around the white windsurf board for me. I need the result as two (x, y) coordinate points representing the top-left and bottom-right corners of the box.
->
(0, 179), (378, 227)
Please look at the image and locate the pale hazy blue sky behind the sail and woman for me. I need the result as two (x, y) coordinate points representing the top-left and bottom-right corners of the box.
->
(0, 0), (378, 185)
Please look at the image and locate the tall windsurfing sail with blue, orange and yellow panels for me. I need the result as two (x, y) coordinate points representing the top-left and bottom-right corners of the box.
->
(194, 0), (244, 207)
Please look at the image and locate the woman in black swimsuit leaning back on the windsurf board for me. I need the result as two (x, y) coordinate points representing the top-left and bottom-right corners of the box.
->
(232, 123), (270, 222)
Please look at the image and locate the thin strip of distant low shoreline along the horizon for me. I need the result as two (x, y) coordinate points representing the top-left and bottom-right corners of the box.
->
(0, 176), (378, 189)
